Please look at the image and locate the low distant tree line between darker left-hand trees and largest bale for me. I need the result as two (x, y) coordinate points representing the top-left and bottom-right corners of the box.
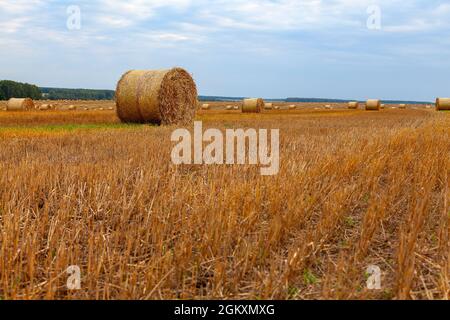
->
(40, 88), (115, 100)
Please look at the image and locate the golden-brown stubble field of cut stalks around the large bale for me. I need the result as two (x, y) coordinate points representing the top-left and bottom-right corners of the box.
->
(0, 103), (450, 299)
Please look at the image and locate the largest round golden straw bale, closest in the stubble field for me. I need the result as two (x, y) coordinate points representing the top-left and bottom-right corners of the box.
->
(116, 68), (197, 124)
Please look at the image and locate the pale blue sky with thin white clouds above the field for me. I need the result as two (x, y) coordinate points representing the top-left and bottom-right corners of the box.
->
(0, 0), (450, 101)
